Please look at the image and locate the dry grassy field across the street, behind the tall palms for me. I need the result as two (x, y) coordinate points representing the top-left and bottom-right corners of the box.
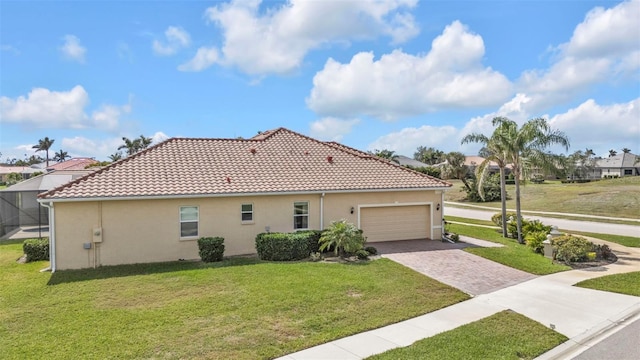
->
(445, 176), (640, 221)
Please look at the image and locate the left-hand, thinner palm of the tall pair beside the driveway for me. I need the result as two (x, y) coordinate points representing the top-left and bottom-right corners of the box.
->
(461, 119), (507, 237)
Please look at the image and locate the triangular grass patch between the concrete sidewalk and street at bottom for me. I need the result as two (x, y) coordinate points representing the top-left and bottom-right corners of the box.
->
(369, 310), (568, 360)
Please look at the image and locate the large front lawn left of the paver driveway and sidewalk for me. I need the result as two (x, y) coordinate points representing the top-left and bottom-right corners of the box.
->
(0, 241), (469, 359)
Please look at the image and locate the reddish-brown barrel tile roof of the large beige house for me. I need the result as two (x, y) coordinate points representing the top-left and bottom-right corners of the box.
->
(40, 128), (451, 200)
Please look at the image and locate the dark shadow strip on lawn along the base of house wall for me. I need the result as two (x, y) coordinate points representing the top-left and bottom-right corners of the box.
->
(47, 257), (264, 285)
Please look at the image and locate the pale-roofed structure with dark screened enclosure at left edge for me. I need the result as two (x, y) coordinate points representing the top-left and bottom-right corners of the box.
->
(0, 170), (91, 236)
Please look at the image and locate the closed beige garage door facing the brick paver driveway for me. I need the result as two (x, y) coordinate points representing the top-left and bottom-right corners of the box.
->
(360, 205), (431, 242)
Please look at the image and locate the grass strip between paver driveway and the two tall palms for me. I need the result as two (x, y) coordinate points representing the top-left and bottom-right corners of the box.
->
(447, 224), (570, 275)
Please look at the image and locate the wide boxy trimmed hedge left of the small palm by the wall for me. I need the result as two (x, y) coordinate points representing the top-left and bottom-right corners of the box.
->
(256, 232), (313, 261)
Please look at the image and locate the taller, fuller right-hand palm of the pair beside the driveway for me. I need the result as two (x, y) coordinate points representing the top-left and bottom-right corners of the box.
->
(492, 117), (569, 243)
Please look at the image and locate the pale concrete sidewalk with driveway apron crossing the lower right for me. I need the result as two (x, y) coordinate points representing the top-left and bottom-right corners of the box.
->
(280, 243), (640, 360)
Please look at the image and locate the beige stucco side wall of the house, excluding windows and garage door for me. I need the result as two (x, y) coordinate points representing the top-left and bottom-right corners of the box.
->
(53, 191), (442, 270)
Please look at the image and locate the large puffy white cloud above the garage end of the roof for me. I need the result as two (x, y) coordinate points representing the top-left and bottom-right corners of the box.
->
(307, 21), (512, 120)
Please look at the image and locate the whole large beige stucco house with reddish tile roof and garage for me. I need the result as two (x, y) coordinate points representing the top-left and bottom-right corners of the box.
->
(39, 128), (451, 271)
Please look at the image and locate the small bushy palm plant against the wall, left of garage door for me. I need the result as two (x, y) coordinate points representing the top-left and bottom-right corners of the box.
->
(318, 219), (366, 257)
